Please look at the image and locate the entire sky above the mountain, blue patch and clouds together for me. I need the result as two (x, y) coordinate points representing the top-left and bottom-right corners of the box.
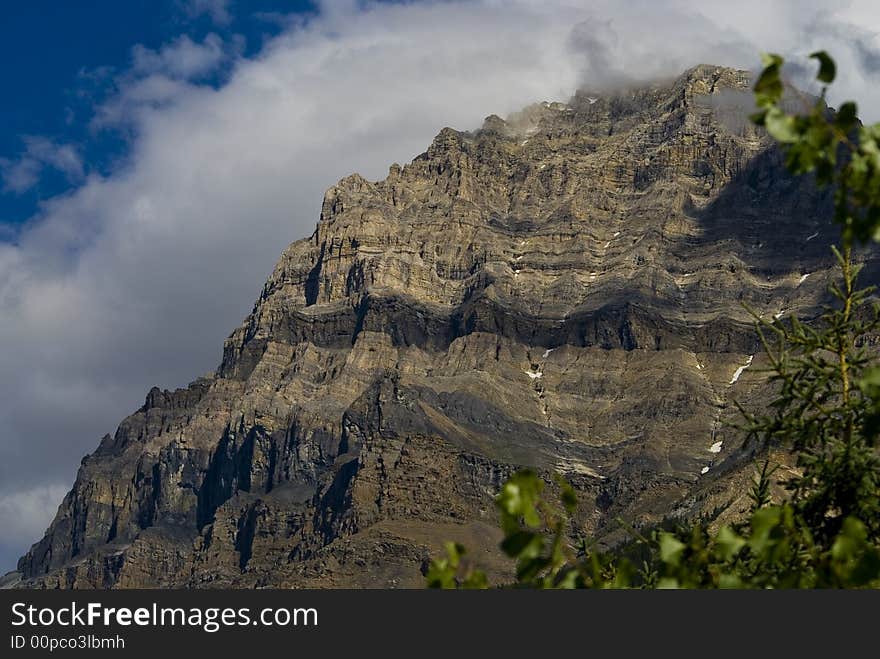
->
(0, 0), (880, 572)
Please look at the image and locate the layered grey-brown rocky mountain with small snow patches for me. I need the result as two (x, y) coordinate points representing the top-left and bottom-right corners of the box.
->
(10, 66), (877, 587)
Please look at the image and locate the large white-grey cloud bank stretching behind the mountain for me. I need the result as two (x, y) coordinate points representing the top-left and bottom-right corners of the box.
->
(0, 0), (880, 572)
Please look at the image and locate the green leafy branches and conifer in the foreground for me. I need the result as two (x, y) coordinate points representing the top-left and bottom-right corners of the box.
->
(427, 52), (880, 588)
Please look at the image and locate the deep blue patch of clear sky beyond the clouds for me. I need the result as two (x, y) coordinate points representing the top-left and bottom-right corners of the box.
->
(0, 0), (315, 232)
